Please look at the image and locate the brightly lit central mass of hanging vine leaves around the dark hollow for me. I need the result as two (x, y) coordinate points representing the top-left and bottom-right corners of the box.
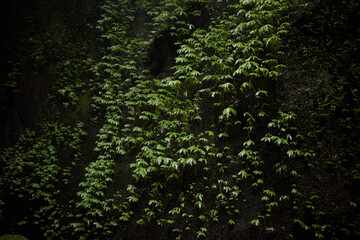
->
(72, 1), (311, 238)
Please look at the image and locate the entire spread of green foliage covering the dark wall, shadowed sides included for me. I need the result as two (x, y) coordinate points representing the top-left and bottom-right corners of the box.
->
(0, 0), (360, 239)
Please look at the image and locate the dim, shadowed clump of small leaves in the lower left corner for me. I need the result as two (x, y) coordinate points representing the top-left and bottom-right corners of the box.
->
(0, 123), (86, 239)
